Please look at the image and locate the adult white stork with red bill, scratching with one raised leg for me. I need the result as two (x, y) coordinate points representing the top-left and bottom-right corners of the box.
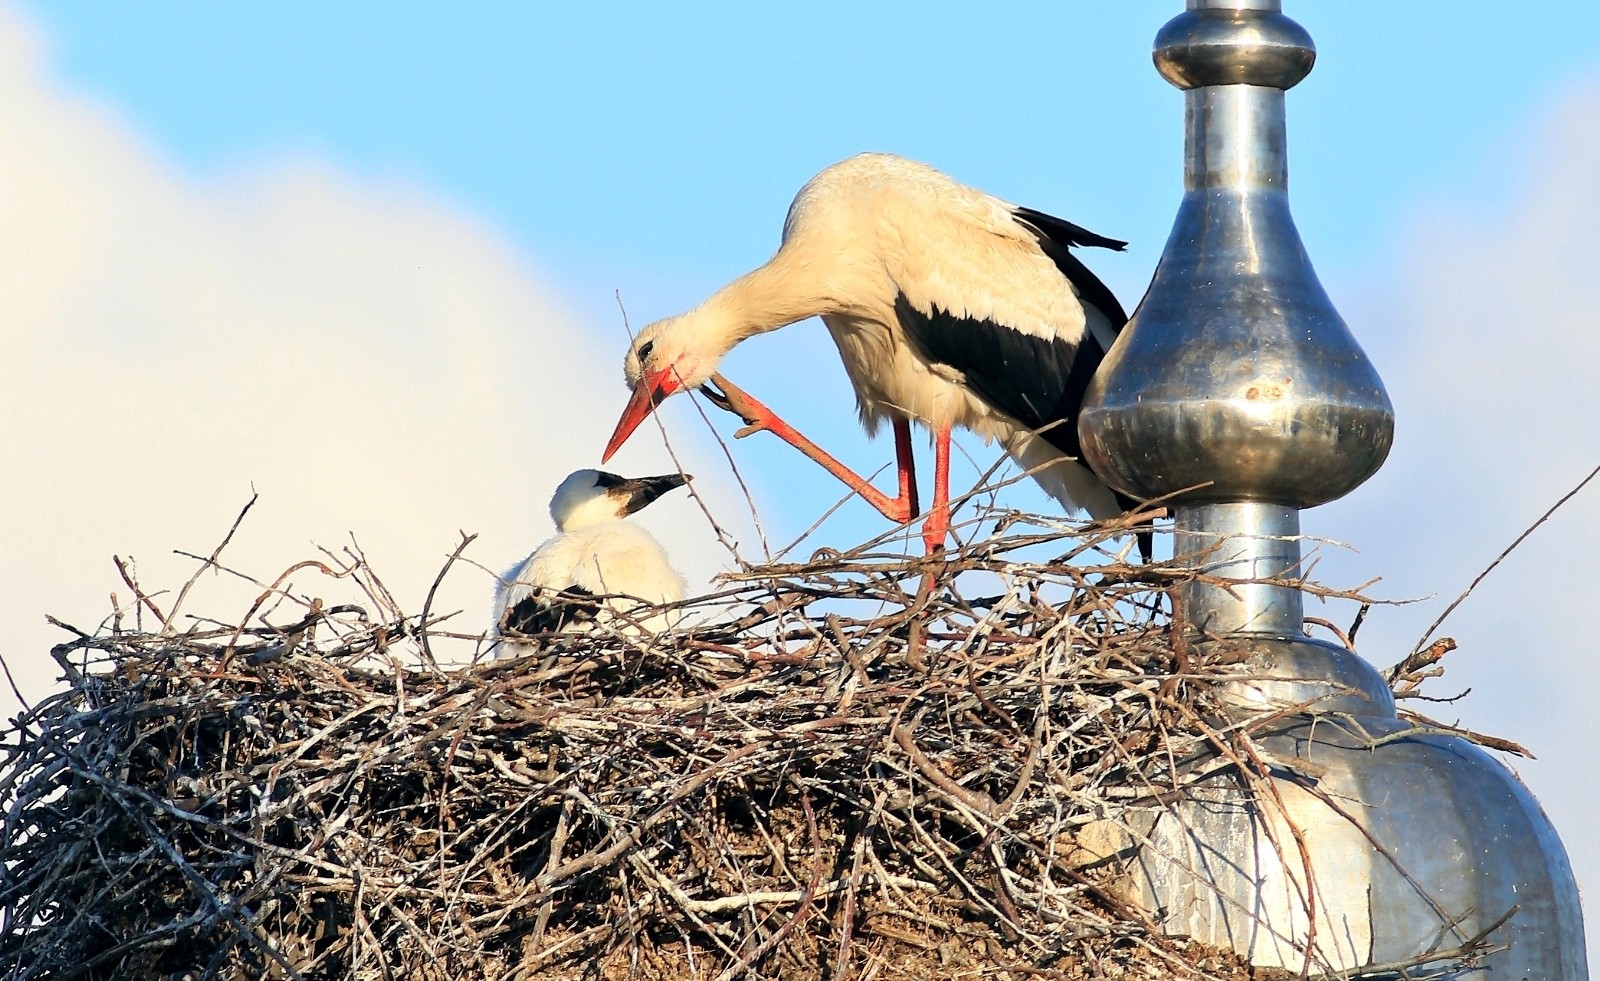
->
(602, 154), (1149, 554)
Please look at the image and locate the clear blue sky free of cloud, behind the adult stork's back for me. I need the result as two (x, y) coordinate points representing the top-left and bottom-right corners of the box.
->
(24, 0), (1600, 531)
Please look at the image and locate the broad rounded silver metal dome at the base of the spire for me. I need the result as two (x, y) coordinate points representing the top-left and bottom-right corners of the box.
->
(1128, 637), (1589, 979)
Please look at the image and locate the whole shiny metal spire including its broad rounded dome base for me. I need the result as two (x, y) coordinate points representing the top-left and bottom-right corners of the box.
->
(1078, 0), (1587, 981)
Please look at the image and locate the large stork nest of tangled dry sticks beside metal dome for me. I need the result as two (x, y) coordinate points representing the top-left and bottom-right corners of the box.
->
(0, 508), (1472, 981)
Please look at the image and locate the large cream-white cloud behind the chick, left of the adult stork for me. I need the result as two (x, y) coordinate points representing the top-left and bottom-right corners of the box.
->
(0, 10), (742, 709)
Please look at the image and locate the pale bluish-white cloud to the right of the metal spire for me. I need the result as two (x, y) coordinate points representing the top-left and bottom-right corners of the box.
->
(1306, 86), (1600, 949)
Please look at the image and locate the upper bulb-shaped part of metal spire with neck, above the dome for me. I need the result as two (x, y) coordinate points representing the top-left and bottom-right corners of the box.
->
(1080, 0), (1394, 635)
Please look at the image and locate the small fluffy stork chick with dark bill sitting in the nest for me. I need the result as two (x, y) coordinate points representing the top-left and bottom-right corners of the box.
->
(493, 470), (688, 658)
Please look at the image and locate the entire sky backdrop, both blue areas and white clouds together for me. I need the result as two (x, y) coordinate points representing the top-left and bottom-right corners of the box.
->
(0, 0), (1600, 966)
